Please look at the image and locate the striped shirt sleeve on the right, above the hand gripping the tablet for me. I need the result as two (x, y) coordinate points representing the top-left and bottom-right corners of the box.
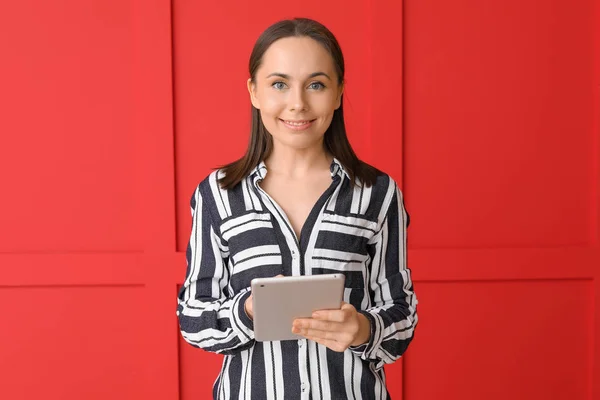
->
(350, 181), (418, 369)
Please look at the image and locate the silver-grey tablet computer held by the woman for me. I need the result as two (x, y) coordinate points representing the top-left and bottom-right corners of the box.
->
(251, 273), (344, 342)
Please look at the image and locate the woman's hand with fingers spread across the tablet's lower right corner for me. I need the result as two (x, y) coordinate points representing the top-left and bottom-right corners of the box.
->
(292, 302), (371, 352)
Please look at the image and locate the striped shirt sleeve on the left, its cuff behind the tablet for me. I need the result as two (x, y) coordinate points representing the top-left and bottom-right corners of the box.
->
(177, 184), (255, 355)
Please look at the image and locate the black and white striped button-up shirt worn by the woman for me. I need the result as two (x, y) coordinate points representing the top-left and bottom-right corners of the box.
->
(177, 159), (418, 399)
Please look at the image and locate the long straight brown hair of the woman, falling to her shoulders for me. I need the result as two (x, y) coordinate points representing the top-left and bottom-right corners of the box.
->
(219, 18), (380, 189)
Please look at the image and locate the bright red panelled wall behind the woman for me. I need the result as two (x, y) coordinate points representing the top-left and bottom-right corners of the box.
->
(0, 0), (600, 400)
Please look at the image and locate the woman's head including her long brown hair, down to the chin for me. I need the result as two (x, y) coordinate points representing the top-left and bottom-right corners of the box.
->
(221, 18), (374, 188)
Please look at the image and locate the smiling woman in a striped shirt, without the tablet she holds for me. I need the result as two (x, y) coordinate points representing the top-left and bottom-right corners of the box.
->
(177, 19), (418, 399)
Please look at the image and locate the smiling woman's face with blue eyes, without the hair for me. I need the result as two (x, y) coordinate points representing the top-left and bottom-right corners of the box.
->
(248, 37), (343, 149)
